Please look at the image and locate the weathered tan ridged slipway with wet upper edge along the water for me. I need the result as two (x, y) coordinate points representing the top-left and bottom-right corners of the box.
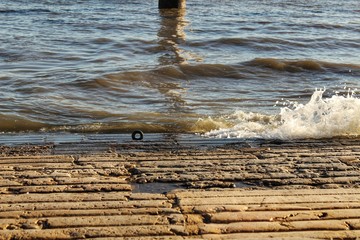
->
(0, 134), (360, 239)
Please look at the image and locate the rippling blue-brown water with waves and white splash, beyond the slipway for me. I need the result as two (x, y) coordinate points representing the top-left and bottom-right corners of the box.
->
(0, 0), (360, 138)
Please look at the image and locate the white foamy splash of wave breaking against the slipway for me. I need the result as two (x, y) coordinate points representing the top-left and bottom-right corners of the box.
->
(205, 89), (360, 139)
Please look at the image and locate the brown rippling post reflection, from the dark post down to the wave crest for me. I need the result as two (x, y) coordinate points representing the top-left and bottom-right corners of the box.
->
(158, 8), (187, 65)
